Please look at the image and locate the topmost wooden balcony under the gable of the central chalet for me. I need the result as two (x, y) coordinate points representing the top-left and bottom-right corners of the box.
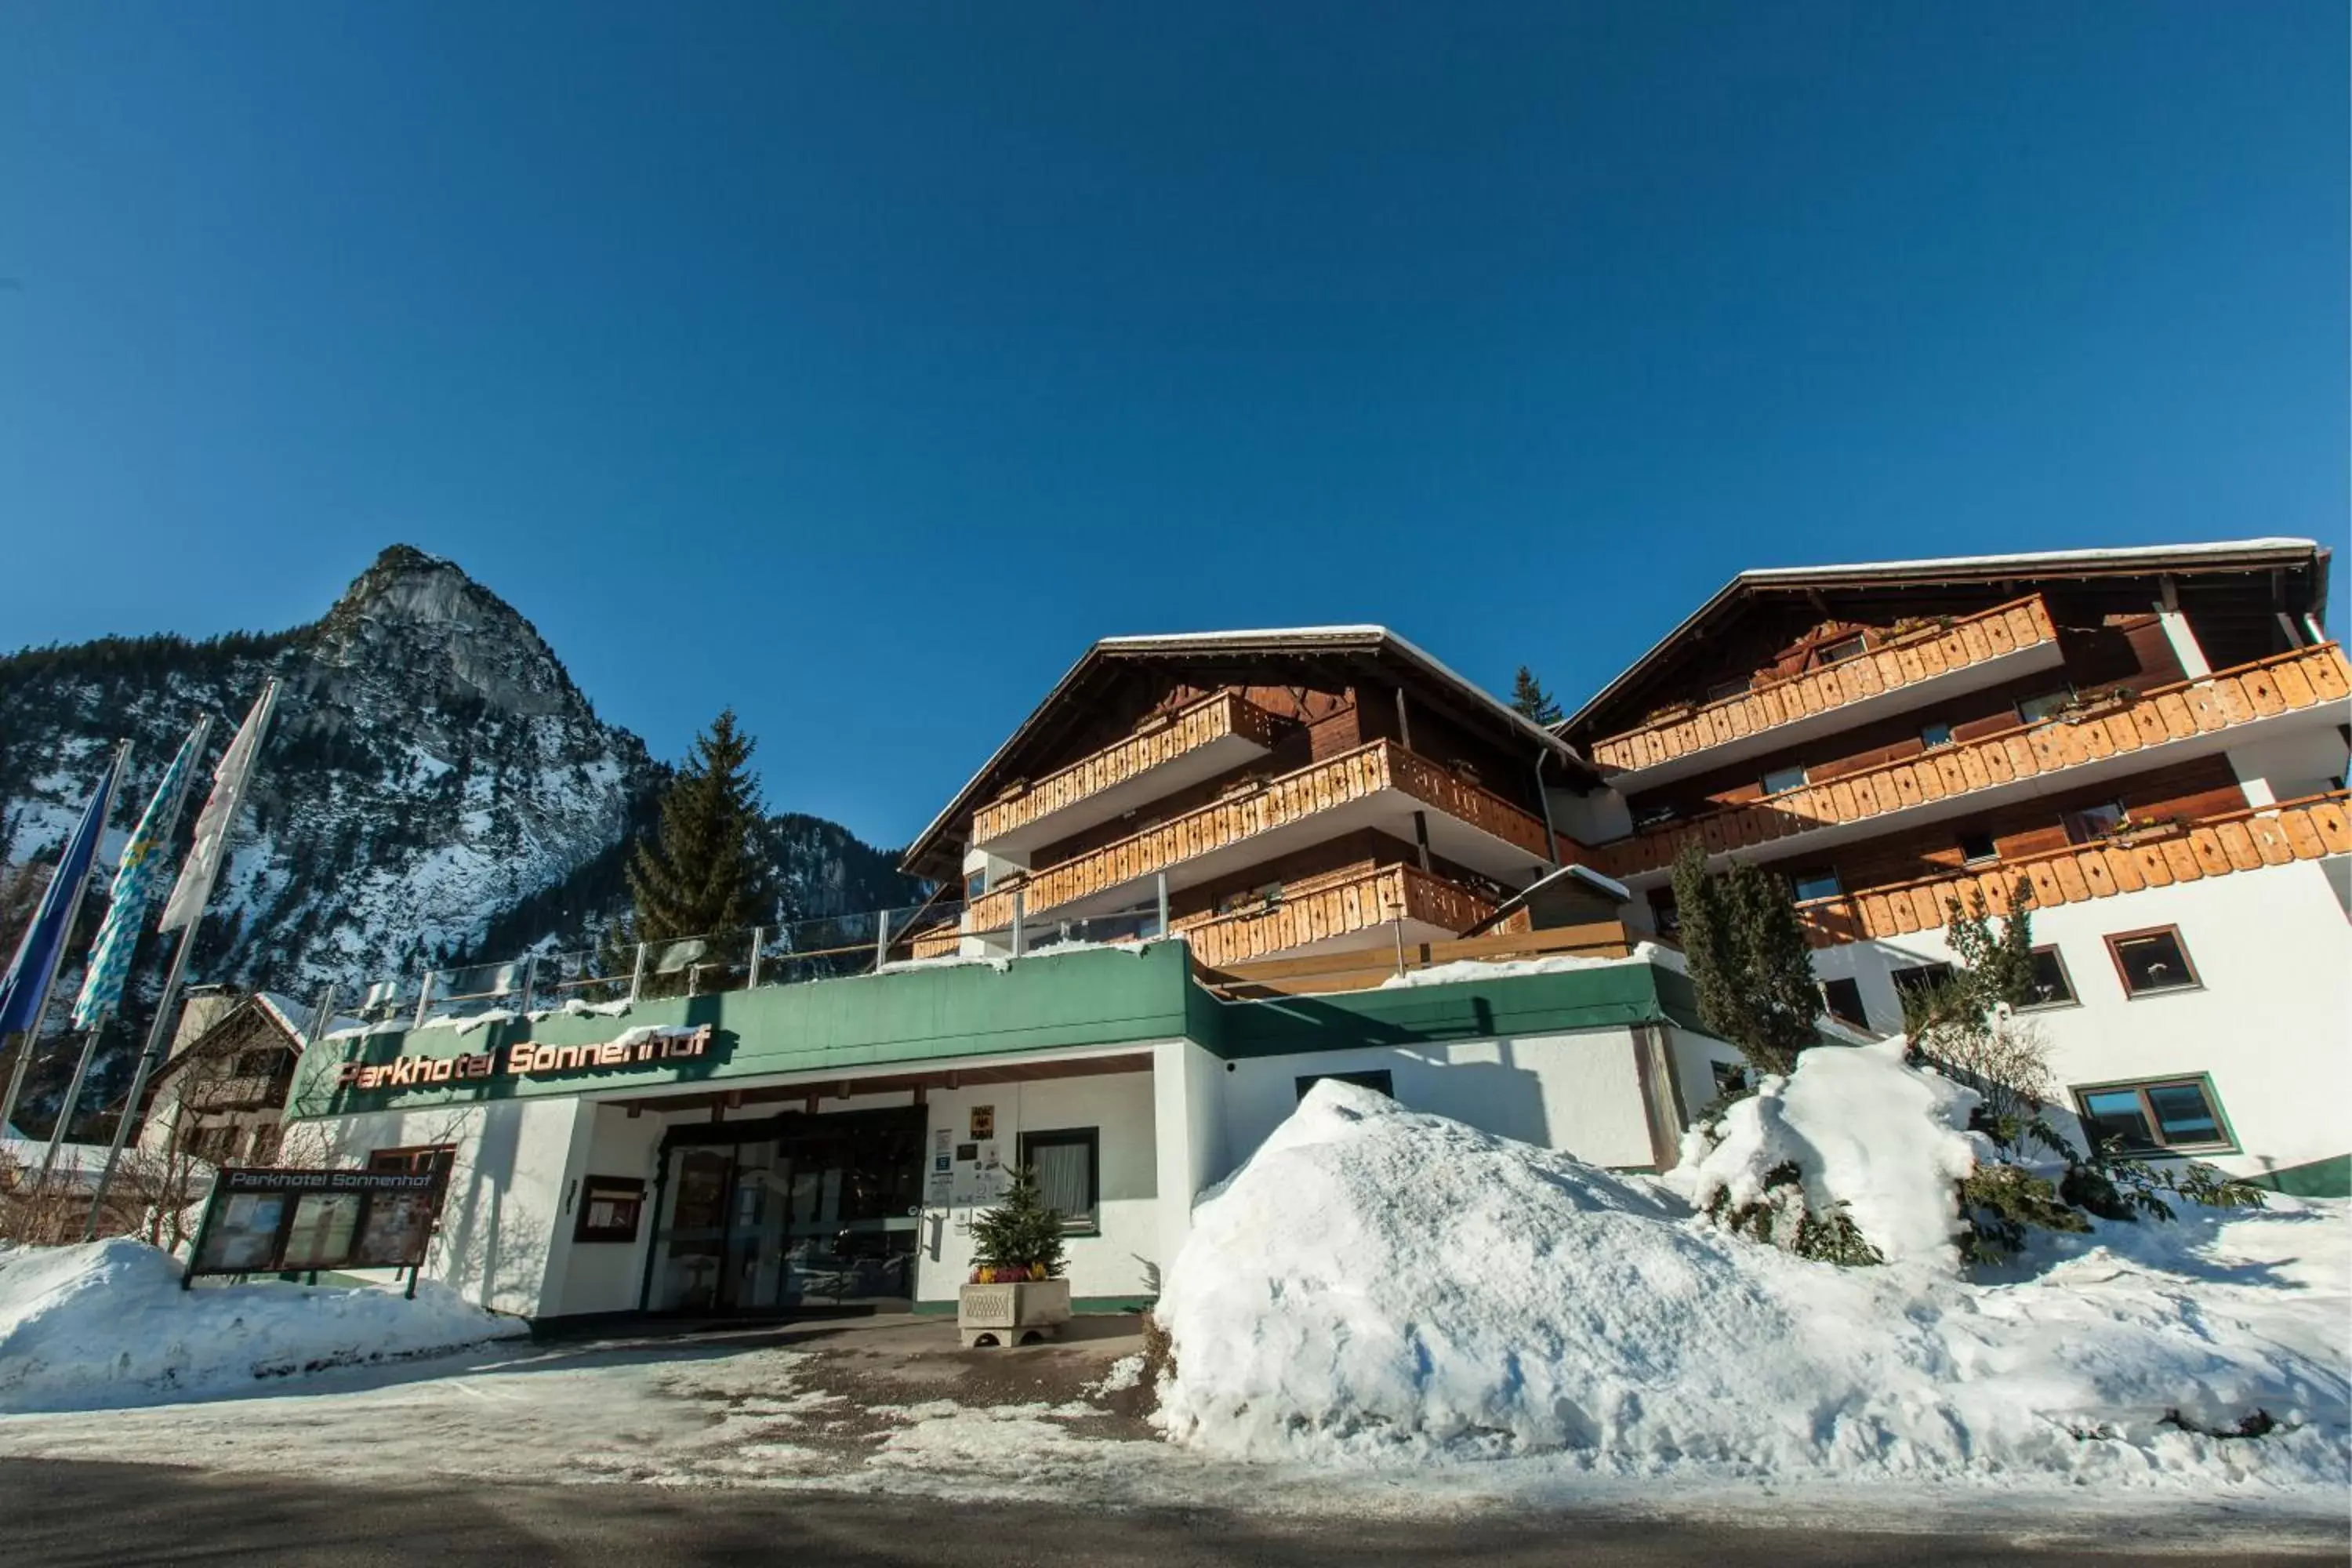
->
(971, 691), (1279, 853)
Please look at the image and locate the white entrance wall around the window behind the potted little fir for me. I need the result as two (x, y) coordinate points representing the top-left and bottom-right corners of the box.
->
(915, 1072), (1164, 1302)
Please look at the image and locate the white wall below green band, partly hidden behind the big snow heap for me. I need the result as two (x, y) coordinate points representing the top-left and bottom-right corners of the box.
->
(1221, 1029), (1651, 1175)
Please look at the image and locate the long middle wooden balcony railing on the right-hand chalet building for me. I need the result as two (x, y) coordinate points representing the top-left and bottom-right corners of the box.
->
(1590, 642), (2352, 877)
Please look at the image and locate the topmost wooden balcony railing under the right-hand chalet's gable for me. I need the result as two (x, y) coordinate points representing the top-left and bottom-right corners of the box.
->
(1585, 595), (2058, 769)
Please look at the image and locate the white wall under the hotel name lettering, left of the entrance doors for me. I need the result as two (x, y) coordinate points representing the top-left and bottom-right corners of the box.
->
(282, 1098), (583, 1316)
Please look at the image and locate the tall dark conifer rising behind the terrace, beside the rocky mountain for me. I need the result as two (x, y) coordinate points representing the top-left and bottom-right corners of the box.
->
(628, 708), (774, 942)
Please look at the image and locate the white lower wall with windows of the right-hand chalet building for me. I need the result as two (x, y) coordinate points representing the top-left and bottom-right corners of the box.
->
(1813, 860), (2352, 1175)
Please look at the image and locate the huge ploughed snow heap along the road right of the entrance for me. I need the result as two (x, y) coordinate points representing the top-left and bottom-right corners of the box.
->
(1157, 1074), (2352, 1488)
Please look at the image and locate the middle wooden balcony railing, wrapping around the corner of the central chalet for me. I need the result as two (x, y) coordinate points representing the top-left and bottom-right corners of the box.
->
(964, 741), (1573, 931)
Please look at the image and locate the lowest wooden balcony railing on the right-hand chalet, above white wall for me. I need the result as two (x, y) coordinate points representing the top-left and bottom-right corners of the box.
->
(1797, 789), (2352, 947)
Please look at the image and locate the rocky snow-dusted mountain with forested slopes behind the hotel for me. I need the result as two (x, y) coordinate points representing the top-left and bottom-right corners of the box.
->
(0, 546), (920, 1027)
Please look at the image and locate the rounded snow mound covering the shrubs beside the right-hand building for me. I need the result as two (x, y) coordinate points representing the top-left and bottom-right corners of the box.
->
(1665, 1036), (1978, 1267)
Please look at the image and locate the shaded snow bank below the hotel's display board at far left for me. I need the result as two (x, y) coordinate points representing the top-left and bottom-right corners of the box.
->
(0, 1236), (527, 1410)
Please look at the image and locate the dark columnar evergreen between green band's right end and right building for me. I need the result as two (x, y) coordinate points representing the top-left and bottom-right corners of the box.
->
(1675, 839), (1820, 1072)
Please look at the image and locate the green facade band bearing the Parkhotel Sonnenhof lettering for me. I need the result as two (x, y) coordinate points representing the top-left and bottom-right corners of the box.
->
(287, 942), (1696, 1119)
